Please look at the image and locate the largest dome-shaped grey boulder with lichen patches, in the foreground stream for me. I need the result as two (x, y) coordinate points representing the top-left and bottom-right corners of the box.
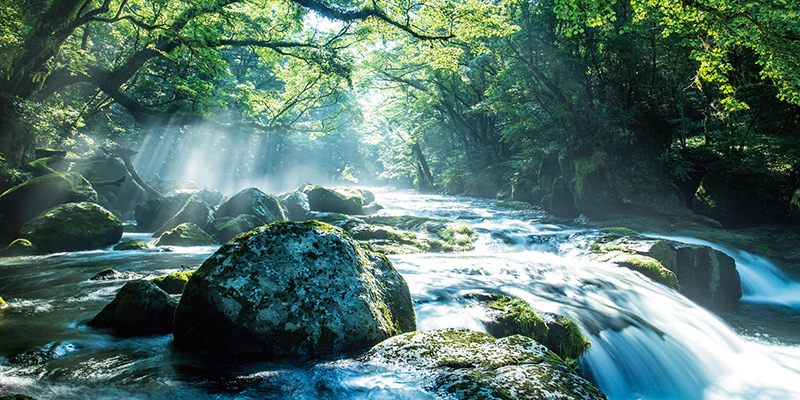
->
(174, 221), (415, 358)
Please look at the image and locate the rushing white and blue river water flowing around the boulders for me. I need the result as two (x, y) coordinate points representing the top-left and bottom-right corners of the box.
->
(0, 193), (800, 400)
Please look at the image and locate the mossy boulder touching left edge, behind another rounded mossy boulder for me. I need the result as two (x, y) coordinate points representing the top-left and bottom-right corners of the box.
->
(0, 172), (97, 229)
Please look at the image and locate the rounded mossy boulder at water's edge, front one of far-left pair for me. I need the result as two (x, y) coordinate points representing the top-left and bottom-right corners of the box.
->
(19, 202), (123, 253)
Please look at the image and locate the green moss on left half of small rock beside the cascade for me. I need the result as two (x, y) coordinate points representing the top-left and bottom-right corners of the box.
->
(488, 294), (548, 343)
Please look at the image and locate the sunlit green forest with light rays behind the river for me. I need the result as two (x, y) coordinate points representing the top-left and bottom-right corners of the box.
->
(0, 0), (800, 228)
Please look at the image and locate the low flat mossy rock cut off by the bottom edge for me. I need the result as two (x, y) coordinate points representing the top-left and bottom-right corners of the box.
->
(363, 330), (606, 400)
